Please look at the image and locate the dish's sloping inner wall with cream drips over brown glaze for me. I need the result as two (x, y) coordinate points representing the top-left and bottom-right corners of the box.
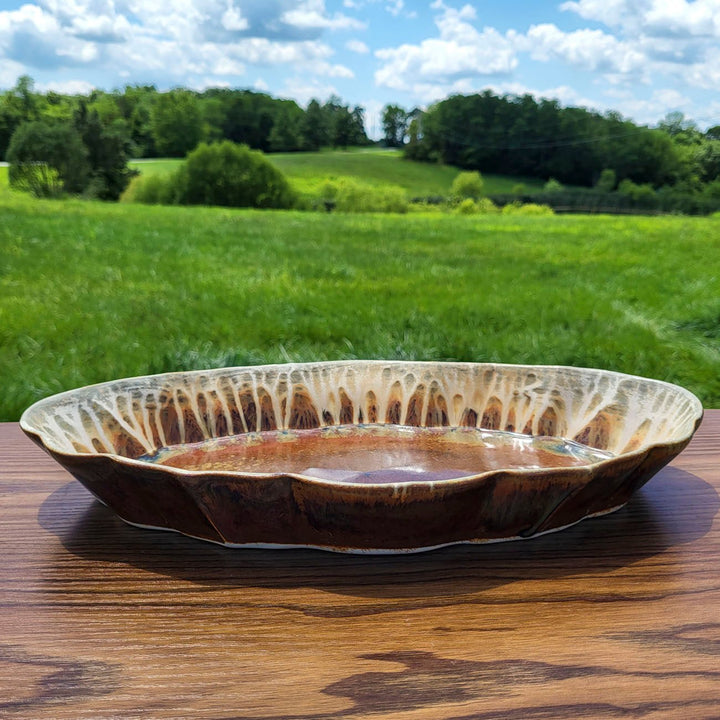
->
(21, 361), (702, 466)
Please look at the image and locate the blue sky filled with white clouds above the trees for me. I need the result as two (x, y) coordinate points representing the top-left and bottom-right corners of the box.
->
(0, 0), (720, 137)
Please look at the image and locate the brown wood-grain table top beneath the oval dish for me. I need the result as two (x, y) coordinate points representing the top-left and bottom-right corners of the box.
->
(0, 410), (720, 720)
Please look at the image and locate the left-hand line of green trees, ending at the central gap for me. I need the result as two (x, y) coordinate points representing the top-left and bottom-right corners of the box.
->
(0, 76), (370, 199)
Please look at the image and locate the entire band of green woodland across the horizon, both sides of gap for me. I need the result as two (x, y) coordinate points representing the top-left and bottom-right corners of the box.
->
(0, 76), (720, 212)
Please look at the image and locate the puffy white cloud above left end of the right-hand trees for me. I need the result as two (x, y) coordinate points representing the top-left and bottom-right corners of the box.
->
(375, 1), (517, 97)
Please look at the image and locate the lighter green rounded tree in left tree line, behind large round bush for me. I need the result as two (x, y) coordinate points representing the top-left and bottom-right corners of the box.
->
(150, 89), (203, 157)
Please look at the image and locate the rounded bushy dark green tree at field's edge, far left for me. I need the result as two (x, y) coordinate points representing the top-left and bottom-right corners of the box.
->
(7, 120), (89, 197)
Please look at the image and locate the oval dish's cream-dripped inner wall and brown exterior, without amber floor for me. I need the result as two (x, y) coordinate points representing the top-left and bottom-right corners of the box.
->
(20, 361), (702, 552)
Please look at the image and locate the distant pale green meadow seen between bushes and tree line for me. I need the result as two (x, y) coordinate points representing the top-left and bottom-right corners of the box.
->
(133, 148), (543, 198)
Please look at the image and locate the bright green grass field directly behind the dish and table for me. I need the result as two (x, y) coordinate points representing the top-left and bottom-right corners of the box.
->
(0, 192), (720, 420)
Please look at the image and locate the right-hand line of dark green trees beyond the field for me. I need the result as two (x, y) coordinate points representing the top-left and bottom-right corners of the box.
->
(394, 91), (720, 197)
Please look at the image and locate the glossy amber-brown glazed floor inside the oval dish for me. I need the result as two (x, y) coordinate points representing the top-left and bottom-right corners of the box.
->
(148, 425), (611, 483)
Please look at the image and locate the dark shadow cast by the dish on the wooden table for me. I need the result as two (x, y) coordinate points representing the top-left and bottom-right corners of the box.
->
(38, 467), (720, 611)
